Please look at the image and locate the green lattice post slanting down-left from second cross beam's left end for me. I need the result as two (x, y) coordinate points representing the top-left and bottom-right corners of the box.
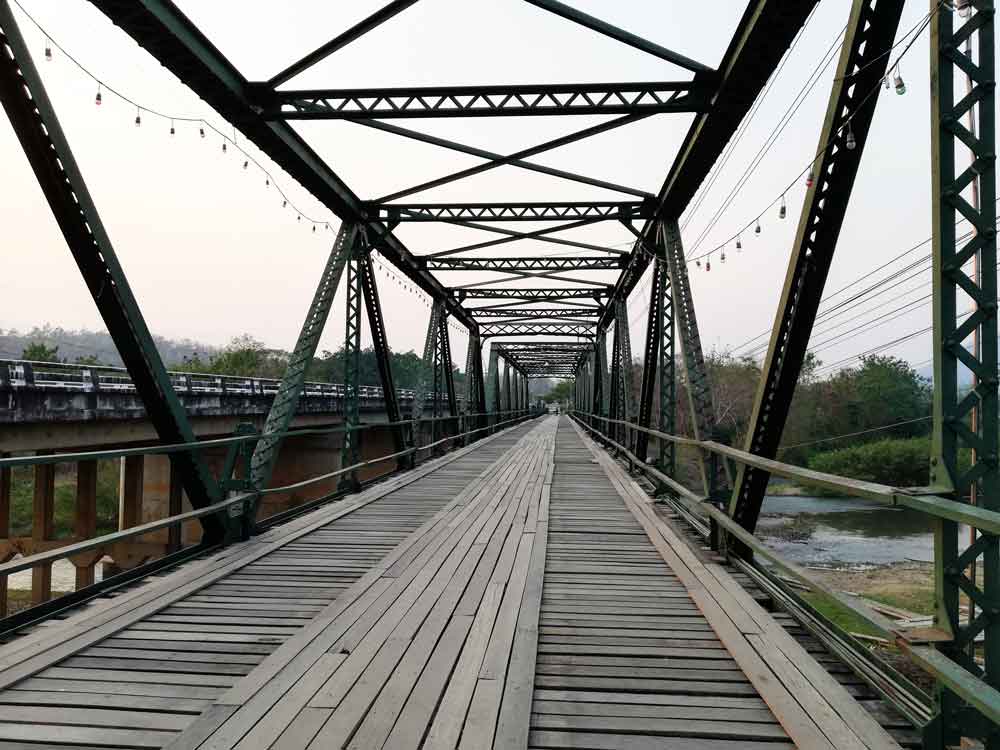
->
(250, 224), (359, 506)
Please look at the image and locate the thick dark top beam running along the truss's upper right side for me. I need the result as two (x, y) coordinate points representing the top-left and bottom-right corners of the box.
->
(601, 0), (817, 326)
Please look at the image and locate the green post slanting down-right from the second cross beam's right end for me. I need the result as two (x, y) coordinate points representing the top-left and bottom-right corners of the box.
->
(659, 220), (717, 497)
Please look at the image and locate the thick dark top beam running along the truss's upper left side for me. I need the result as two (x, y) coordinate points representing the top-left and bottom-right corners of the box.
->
(91, 0), (476, 331)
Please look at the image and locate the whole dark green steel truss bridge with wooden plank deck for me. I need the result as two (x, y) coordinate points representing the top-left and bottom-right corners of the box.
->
(0, 0), (1000, 750)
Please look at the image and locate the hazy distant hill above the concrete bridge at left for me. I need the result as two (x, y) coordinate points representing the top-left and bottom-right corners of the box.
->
(0, 324), (220, 367)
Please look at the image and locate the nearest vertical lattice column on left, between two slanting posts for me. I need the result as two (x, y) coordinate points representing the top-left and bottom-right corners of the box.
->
(340, 242), (367, 490)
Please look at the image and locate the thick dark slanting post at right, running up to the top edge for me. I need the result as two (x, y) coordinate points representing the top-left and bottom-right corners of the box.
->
(730, 0), (903, 531)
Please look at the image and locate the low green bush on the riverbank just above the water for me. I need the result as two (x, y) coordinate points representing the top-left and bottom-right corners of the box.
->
(809, 437), (931, 487)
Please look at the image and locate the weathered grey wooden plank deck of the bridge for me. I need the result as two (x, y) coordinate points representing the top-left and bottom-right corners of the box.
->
(0, 417), (912, 750)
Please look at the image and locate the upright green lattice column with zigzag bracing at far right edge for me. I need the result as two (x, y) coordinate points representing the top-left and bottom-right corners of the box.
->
(925, 0), (1000, 750)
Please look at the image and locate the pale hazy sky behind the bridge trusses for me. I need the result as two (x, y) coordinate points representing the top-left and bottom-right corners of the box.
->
(0, 0), (984, 382)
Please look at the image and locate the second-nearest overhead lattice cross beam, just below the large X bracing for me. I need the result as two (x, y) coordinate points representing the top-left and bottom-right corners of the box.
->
(369, 201), (653, 222)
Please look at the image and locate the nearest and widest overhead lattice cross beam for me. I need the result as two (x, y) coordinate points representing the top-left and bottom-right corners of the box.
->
(254, 81), (708, 120)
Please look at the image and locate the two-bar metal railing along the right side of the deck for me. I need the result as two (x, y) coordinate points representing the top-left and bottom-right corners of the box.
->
(570, 411), (1000, 736)
